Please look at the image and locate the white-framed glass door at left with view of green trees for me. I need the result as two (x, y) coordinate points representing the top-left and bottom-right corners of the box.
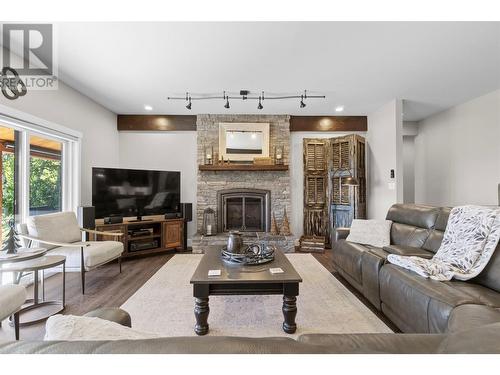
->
(0, 118), (80, 244)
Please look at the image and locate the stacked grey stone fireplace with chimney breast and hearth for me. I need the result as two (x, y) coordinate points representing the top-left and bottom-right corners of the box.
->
(193, 115), (295, 253)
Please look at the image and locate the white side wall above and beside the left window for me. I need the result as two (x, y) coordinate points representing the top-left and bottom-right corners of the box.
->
(0, 82), (118, 205)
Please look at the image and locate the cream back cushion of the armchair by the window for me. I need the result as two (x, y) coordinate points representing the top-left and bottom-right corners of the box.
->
(27, 212), (82, 249)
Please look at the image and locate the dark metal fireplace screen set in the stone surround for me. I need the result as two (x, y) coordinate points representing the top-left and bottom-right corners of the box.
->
(218, 189), (270, 232)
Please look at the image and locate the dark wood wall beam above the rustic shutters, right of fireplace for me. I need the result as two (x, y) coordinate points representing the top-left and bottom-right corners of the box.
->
(290, 116), (368, 132)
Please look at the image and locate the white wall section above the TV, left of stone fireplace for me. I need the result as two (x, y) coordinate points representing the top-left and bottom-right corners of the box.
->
(118, 131), (198, 246)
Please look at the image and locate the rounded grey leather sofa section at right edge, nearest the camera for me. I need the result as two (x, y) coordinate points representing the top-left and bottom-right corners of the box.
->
(447, 305), (500, 332)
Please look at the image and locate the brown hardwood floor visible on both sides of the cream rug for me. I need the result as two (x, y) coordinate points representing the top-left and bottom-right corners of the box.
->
(0, 250), (395, 340)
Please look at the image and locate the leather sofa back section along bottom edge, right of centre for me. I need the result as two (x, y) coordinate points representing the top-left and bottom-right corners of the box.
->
(297, 333), (445, 354)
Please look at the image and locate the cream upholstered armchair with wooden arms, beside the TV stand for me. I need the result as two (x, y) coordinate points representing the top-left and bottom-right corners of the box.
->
(19, 212), (123, 294)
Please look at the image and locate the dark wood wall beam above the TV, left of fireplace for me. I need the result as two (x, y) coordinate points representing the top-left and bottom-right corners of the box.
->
(117, 115), (196, 131)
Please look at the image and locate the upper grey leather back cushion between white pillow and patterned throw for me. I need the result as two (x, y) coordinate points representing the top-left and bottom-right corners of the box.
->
(386, 204), (440, 229)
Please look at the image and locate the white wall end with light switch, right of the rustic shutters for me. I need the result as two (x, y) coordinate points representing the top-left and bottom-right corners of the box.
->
(366, 99), (403, 219)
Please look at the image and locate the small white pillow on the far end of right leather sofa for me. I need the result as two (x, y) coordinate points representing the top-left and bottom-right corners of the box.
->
(346, 219), (392, 247)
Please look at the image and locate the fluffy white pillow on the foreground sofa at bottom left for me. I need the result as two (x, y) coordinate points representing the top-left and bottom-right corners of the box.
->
(44, 314), (160, 341)
